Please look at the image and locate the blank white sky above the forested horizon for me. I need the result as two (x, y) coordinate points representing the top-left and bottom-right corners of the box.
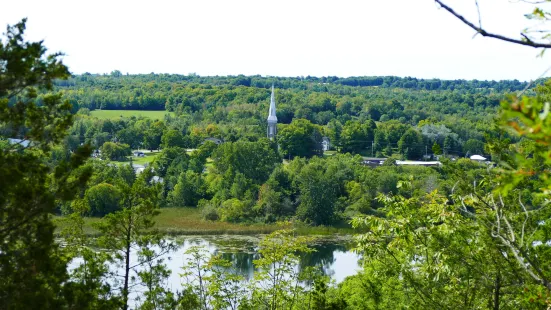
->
(0, 0), (551, 80)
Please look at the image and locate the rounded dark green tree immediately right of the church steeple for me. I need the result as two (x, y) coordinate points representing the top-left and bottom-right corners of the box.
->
(278, 119), (322, 158)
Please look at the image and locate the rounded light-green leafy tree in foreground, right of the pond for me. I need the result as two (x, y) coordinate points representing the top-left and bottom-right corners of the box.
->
(354, 189), (521, 309)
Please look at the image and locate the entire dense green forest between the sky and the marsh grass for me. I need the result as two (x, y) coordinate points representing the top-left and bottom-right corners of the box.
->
(44, 71), (534, 225)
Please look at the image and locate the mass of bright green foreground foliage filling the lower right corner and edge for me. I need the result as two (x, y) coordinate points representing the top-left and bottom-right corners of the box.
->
(353, 86), (551, 309)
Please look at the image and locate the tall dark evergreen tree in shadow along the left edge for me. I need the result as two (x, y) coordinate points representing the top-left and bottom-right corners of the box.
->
(0, 19), (90, 309)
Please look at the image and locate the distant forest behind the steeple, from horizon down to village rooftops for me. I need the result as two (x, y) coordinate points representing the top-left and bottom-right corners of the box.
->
(49, 71), (540, 159)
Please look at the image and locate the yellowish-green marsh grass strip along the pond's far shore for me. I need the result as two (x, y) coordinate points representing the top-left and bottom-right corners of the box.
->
(57, 208), (357, 235)
